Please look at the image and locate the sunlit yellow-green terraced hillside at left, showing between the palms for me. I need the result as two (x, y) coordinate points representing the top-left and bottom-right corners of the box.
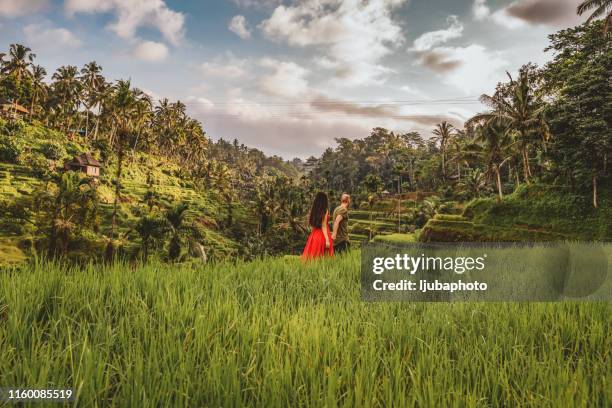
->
(0, 121), (243, 264)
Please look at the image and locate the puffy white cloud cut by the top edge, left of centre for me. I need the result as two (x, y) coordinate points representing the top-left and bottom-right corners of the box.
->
(65, 0), (185, 45)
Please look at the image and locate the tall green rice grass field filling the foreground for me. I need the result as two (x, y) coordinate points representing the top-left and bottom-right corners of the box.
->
(0, 252), (612, 407)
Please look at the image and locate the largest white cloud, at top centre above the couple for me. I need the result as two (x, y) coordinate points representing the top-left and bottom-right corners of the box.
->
(260, 0), (406, 85)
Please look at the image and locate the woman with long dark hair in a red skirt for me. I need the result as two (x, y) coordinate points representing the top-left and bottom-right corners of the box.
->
(302, 192), (334, 260)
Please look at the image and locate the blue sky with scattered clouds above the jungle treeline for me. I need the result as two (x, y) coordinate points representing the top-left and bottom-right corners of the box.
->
(0, 0), (585, 159)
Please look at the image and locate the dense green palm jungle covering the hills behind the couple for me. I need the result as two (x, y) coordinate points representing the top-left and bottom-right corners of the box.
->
(0, 21), (612, 262)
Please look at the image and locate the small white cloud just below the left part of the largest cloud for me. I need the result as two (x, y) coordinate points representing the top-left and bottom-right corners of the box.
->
(259, 58), (309, 98)
